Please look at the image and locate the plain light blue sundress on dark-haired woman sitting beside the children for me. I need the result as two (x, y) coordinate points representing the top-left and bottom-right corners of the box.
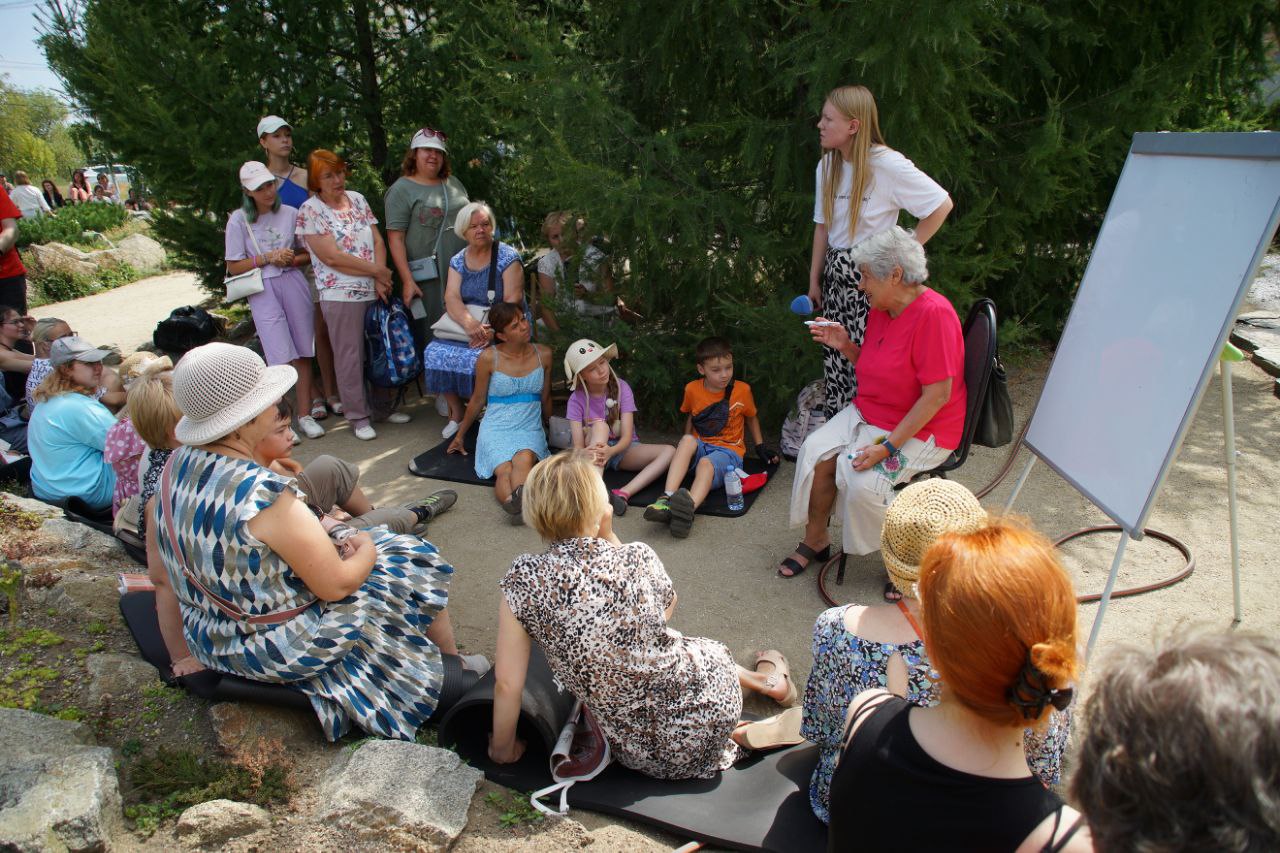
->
(476, 347), (550, 479)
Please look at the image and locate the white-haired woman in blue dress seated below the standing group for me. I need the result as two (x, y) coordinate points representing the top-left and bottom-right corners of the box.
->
(422, 201), (525, 438)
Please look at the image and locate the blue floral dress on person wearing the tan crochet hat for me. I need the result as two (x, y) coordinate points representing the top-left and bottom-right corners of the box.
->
(800, 605), (1071, 824)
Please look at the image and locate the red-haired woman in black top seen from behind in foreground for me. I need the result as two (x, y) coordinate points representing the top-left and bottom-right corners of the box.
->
(828, 520), (1092, 852)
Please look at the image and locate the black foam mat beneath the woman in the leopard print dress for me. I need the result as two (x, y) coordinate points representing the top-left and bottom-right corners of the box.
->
(439, 646), (827, 853)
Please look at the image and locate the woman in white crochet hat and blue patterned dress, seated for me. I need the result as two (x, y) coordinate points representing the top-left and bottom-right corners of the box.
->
(147, 343), (488, 740)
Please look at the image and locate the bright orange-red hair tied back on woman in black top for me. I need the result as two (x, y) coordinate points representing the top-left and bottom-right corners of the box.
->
(919, 519), (1079, 727)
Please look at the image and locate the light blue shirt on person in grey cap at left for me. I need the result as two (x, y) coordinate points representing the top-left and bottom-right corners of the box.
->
(27, 393), (115, 510)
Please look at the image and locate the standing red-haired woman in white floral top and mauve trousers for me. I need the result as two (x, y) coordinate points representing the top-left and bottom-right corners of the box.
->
(297, 149), (408, 441)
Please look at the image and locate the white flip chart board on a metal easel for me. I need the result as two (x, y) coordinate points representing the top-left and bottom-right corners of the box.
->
(1007, 132), (1280, 653)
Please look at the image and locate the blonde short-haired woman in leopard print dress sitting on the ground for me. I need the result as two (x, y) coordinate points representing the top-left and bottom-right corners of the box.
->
(489, 451), (795, 779)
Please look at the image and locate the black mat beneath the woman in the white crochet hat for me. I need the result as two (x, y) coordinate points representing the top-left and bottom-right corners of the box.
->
(120, 590), (476, 725)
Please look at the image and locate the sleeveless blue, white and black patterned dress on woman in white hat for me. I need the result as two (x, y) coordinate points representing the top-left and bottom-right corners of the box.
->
(152, 447), (453, 740)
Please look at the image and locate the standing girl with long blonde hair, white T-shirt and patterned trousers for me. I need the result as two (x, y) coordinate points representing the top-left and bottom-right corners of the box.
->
(809, 86), (952, 418)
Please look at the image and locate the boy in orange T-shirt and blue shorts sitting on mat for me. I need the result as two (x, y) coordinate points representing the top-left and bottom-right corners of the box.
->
(644, 338), (777, 539)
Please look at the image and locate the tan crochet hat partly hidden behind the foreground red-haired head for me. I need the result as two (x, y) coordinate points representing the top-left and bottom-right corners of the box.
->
(881, 478), (987, 598)
